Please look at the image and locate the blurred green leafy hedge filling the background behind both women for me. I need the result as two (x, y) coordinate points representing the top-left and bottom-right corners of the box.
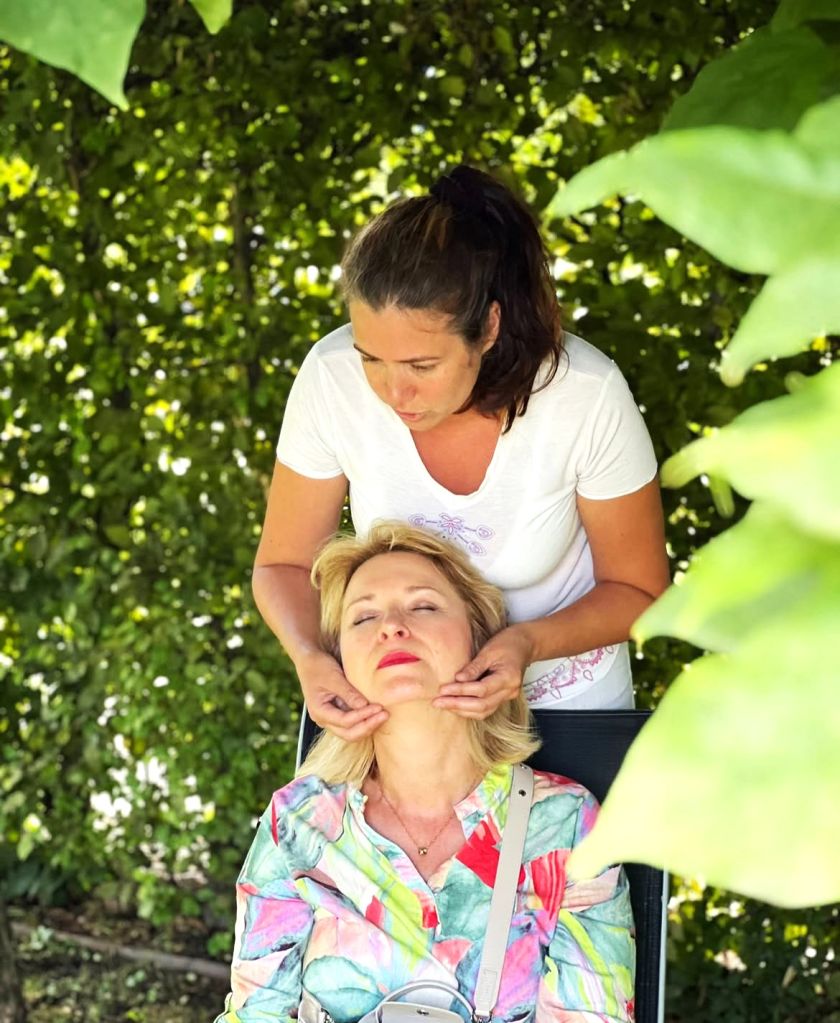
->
(0, 0), (840, 1023)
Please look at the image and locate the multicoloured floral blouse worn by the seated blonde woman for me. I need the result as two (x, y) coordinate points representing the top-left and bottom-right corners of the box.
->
(216, 765), (635, 1023)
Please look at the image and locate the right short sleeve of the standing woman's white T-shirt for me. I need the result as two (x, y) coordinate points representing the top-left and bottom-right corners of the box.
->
(576, 365), (657, 500)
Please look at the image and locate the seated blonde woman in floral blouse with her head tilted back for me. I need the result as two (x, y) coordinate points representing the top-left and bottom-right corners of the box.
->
(217, 523), (634, 1023)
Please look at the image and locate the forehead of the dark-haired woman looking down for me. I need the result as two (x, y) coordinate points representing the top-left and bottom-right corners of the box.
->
(350, 302), (466, 361)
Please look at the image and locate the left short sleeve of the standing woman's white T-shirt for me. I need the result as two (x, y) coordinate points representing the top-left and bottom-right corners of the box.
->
(277, 345), (343, 480)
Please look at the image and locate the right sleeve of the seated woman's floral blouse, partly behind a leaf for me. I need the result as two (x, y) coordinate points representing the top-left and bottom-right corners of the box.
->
(536, 793), (635, 1023)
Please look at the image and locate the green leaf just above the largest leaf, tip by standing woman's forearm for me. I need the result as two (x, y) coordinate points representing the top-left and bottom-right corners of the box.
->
(633, 504), (840, 652)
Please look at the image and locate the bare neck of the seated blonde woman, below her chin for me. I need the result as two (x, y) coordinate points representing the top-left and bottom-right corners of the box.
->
(366, 702), (479, 814)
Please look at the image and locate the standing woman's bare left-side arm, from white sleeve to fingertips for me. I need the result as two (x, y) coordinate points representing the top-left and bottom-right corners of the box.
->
(252, 461), (388, 742)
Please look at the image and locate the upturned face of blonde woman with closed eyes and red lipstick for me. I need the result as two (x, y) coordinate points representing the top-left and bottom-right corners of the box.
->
(340, 551), (472, 707)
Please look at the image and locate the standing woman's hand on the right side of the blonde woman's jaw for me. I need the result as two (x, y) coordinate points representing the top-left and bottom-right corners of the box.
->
(433, 625), (533, 718)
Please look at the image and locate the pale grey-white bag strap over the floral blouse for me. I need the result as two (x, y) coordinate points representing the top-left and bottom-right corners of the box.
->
(473, 764), (534, 1023)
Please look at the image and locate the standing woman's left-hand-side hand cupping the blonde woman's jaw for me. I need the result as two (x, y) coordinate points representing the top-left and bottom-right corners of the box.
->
(297, 651), (388, 743)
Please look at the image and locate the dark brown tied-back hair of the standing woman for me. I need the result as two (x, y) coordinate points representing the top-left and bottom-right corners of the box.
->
(342, 165), (563, 431)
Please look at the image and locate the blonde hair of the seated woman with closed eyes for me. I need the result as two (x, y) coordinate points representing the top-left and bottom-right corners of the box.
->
(298, 522), (540, 785)
